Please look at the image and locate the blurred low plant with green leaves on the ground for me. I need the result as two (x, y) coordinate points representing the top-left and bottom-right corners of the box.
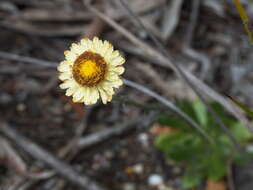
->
(155, 100), (252, 189)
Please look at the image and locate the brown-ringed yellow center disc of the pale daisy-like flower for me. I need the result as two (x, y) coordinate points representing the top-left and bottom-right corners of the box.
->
(72, 51), (107, 87)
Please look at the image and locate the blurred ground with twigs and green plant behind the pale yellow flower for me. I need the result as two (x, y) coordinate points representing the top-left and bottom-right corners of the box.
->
(0, 0), (253, 190)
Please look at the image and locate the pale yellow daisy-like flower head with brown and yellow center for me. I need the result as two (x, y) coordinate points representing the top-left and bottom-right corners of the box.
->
(58, 37), (125, 105)
